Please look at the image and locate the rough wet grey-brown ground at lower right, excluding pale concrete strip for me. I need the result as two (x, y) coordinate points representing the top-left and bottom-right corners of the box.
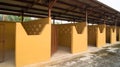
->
(47, 44), (120, 67)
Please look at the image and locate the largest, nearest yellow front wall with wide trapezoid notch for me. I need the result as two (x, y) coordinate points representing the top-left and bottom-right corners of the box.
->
(16, 18), (51, 67)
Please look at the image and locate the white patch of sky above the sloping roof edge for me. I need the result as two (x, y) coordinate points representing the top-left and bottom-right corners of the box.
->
(98, 0), (120, 12)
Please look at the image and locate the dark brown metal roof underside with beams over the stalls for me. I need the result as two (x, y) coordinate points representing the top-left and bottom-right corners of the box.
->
(0, 0), (120, 25)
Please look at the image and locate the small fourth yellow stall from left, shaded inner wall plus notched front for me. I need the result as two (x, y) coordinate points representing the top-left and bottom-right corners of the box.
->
(106, 26), (116, 44)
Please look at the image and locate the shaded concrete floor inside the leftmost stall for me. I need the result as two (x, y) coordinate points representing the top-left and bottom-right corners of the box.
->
(0, 50), (15, 67)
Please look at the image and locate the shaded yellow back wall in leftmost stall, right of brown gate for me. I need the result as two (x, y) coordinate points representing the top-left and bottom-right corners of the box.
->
(0, 21), (16, 51)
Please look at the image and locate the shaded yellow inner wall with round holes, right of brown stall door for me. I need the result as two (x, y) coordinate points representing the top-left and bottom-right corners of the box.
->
(56, 24), (72, 47)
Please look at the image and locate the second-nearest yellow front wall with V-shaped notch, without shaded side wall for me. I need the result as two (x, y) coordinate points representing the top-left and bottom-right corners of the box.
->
(71, 22), (88, 53)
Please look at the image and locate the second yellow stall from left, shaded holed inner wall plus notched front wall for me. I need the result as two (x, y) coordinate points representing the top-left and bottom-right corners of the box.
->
(56, 22), (88, 54)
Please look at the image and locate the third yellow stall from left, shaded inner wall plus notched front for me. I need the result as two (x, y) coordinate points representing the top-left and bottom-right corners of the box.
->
(88, 24), (106, 48)
